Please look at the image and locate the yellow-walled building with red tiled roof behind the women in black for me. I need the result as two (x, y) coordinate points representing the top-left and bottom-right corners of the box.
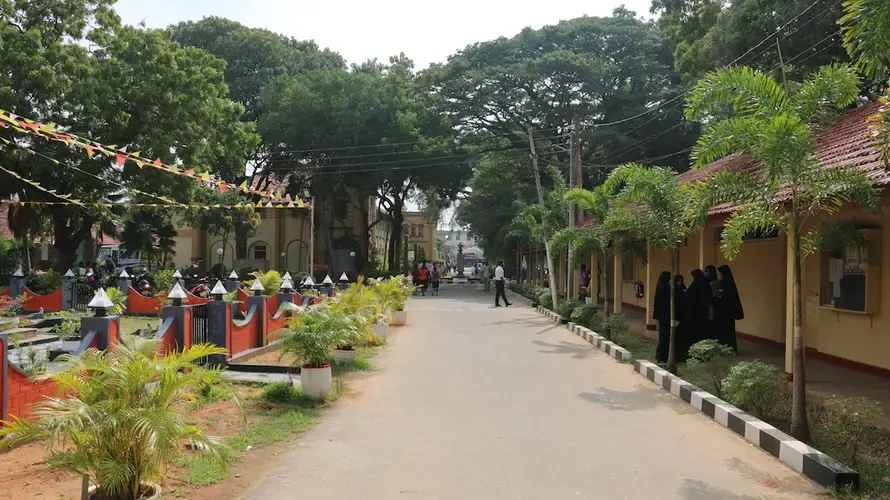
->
(532, 103), (890, 376)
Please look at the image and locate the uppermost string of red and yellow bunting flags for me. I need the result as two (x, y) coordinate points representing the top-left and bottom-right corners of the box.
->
(0, 109), (309, 208)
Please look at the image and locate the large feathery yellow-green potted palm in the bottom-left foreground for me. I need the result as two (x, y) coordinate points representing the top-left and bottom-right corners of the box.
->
(0, 335), (228, 500)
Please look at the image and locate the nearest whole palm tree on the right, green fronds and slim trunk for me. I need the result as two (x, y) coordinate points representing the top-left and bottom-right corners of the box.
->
(686, 65), (879, 440)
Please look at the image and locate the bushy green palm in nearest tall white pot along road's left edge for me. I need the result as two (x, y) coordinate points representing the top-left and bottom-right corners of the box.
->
(281, 306), (356, 401)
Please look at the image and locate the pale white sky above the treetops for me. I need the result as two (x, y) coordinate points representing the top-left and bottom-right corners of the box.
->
(116, 0), (651, 69)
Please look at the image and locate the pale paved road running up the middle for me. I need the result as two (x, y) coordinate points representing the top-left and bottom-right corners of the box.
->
(252, 288), (822, 500)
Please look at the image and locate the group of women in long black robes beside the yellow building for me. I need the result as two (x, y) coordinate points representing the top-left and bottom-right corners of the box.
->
(653, 265), (745, 363)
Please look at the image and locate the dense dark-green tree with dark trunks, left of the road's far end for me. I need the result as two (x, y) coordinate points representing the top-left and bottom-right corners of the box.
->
(259, 56), (471, 272)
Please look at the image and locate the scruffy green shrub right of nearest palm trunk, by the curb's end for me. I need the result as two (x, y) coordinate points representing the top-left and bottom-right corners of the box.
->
(814, 397), (883, 469)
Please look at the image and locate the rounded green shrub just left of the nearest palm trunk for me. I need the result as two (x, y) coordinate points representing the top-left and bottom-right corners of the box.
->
(721, 359), (785, 420)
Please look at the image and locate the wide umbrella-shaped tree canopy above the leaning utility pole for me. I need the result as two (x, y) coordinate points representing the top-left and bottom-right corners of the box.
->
(423, 8), (695, 174)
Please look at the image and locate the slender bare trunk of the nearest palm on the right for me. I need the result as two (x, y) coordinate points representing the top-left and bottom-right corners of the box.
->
(791, 209), (810, 441)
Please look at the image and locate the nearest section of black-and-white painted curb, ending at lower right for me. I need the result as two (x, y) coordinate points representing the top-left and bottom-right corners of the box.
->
(634, 359), (859, 488)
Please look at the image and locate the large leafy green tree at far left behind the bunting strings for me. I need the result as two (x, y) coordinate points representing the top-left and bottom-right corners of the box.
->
(0, 0), (256, 269)
